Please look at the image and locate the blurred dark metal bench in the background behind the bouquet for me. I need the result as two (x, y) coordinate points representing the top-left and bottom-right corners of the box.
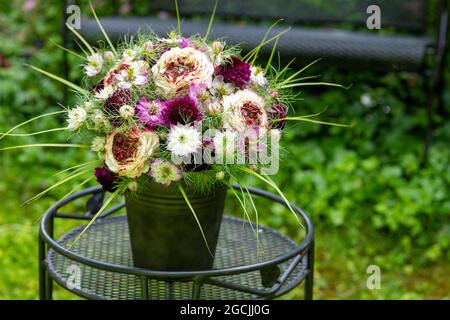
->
(62, 0), (448, 160)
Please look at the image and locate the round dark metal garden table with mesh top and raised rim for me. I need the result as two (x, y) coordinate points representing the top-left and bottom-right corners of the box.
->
(39, 186), (314, 300)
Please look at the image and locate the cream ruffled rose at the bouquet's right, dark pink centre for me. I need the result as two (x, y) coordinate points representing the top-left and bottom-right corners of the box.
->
(222, 89), (269, 131)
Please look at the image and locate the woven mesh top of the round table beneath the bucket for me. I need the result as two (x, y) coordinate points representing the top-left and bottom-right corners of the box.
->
(46, 216), (306, 300)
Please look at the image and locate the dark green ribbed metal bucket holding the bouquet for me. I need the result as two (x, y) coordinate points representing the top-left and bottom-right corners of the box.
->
(125, 182), (226, 271)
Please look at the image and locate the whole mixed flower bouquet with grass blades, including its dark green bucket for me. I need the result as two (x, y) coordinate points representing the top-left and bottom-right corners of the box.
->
(0, 2), (348, 270)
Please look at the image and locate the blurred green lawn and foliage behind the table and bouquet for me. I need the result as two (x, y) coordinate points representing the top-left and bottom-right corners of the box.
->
(0, 0), (450, 299)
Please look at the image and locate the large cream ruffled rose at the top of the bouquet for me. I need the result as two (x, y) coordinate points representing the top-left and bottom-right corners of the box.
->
(152, 47), (214, 99)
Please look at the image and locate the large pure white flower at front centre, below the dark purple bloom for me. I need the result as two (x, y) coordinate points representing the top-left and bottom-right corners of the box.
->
(167, 124), (202, 157)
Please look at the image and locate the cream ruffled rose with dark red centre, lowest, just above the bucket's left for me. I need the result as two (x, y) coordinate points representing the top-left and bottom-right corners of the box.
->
(105, 130), (159, 178)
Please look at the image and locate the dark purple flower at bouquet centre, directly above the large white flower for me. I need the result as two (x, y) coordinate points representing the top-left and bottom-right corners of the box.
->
(161, 96), (203, 127)
